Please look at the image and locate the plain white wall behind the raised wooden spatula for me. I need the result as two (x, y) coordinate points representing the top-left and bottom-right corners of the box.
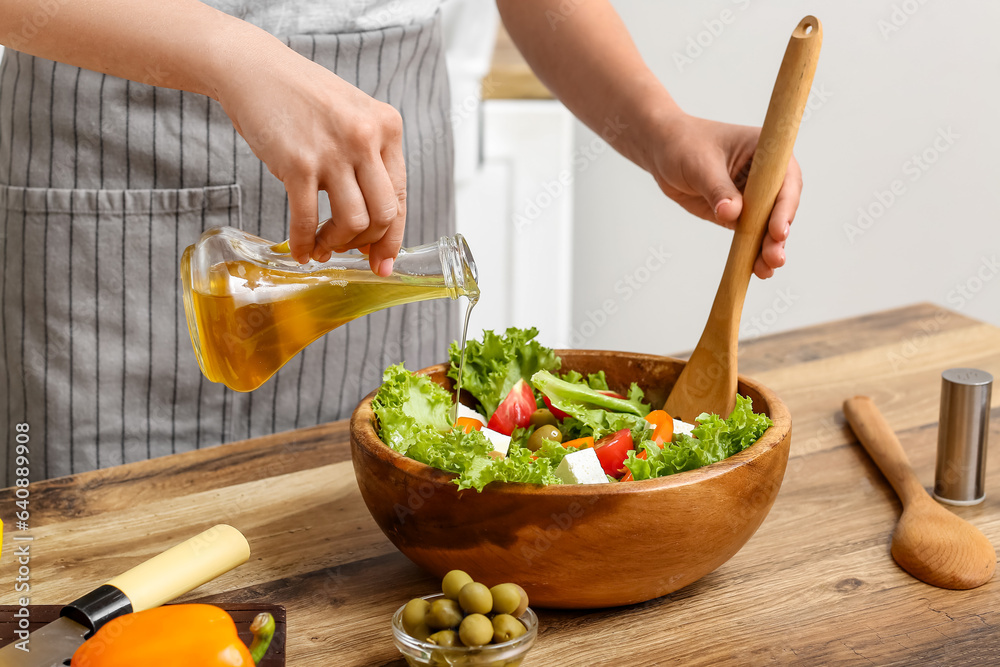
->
(573, 0), (1000, 354)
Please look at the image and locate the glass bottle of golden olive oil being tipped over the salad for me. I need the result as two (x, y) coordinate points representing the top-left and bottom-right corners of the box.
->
(181, 232), (479, 391)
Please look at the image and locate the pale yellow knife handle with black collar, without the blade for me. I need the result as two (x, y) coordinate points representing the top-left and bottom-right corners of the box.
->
(61, 524), (250, 632)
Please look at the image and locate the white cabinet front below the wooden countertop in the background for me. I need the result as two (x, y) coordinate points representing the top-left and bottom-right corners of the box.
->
(456, 100), (573, 347)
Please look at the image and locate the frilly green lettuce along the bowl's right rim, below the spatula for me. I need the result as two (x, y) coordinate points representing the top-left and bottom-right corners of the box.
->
(625, 396), (771, 480)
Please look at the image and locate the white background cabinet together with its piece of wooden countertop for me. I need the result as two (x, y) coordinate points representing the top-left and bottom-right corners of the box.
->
(444, 0), (574, 347)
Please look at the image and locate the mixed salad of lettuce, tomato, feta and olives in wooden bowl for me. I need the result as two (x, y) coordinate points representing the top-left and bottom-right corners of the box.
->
(372, 328), (771, 491)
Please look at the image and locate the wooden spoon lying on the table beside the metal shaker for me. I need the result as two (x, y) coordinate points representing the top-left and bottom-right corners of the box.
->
(844, 396), (997, 589)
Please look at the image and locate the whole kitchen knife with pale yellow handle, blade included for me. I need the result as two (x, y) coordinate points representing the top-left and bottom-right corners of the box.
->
(0, 524), (250, 667)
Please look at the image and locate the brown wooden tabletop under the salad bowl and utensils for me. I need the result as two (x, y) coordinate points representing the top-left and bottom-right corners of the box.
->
(0, 305), (1000, 667)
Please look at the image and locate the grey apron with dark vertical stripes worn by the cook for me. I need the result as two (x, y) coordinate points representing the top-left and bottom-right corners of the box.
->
(0, 18), (457, 486)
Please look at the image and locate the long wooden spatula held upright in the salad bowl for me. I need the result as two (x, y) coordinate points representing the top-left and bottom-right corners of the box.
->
(663, 16), (823, 422)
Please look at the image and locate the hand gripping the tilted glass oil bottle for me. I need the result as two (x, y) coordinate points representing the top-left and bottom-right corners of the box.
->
(218, 34), (406, 276)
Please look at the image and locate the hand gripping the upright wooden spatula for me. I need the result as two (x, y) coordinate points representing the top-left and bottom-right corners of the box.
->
(649, 112), (802, 278)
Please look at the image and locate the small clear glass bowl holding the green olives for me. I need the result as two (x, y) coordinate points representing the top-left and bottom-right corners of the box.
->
(392, 593), (538, 667)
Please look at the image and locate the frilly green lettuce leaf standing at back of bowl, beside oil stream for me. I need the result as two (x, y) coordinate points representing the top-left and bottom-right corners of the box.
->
(448, 327), (561, 417)
